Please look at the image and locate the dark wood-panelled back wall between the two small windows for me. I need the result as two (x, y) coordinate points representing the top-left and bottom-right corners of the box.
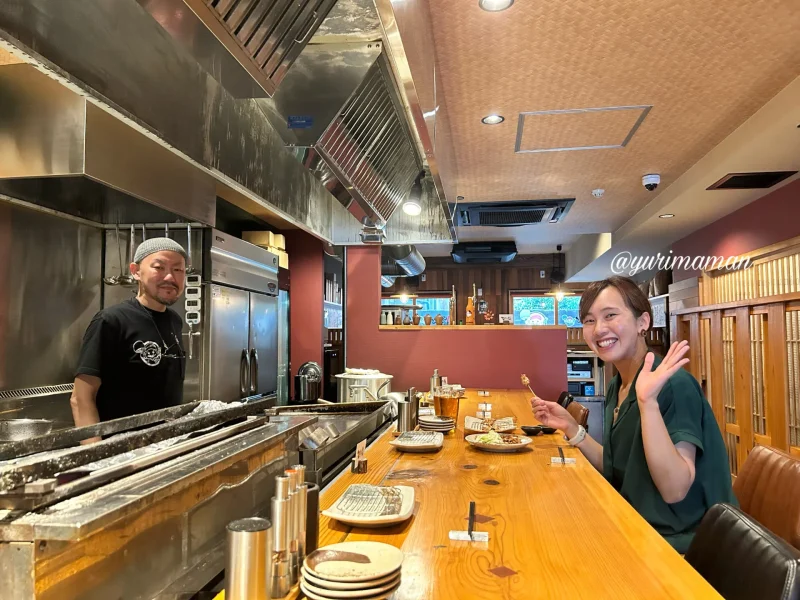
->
(383, 254), (586, 323)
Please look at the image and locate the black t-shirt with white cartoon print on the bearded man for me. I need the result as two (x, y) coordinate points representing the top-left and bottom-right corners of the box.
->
(76, 298), (186, 421)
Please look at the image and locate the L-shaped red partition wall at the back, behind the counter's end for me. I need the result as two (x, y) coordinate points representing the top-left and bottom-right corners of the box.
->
(345, 247), (567, 400)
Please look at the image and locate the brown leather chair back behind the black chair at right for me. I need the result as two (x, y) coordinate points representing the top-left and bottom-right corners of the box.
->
(733, 446), (800, 549)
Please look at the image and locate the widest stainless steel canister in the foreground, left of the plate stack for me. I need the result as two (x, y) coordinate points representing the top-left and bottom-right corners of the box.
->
(225, 517), (272, 600)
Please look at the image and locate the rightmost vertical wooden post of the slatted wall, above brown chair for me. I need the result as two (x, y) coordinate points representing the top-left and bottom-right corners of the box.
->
(764, 304), (789, 451)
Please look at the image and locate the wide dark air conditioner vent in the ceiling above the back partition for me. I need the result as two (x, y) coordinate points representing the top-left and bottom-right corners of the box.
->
(451, 198), (575, 227)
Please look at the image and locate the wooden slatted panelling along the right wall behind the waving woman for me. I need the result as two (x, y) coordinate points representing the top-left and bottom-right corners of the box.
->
(670, 238), (800, 475)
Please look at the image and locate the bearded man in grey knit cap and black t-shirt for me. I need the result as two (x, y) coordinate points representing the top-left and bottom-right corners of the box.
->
(70, 237), (186, 427)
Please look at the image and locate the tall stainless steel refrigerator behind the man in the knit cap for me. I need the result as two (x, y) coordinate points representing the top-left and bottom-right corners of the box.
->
(199, 229), (278, 402)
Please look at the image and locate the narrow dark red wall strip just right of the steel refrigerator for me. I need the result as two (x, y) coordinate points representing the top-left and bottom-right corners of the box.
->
(283, 229), (325, 394)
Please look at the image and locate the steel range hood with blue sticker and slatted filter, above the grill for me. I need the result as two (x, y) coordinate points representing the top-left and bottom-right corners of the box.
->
(257, 42), (422, 229)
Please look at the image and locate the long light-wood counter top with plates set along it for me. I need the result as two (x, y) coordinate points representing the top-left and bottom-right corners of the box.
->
(289, 390), (720, 600)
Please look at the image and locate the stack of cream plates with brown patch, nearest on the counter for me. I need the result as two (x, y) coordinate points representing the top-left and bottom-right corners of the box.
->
(300, 542), (403, 600)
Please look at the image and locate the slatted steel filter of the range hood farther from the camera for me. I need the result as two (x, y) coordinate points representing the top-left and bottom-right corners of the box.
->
(317, 55), (421, 222)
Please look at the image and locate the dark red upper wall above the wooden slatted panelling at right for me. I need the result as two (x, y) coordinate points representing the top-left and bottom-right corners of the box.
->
(672, 179), (800, 281)
